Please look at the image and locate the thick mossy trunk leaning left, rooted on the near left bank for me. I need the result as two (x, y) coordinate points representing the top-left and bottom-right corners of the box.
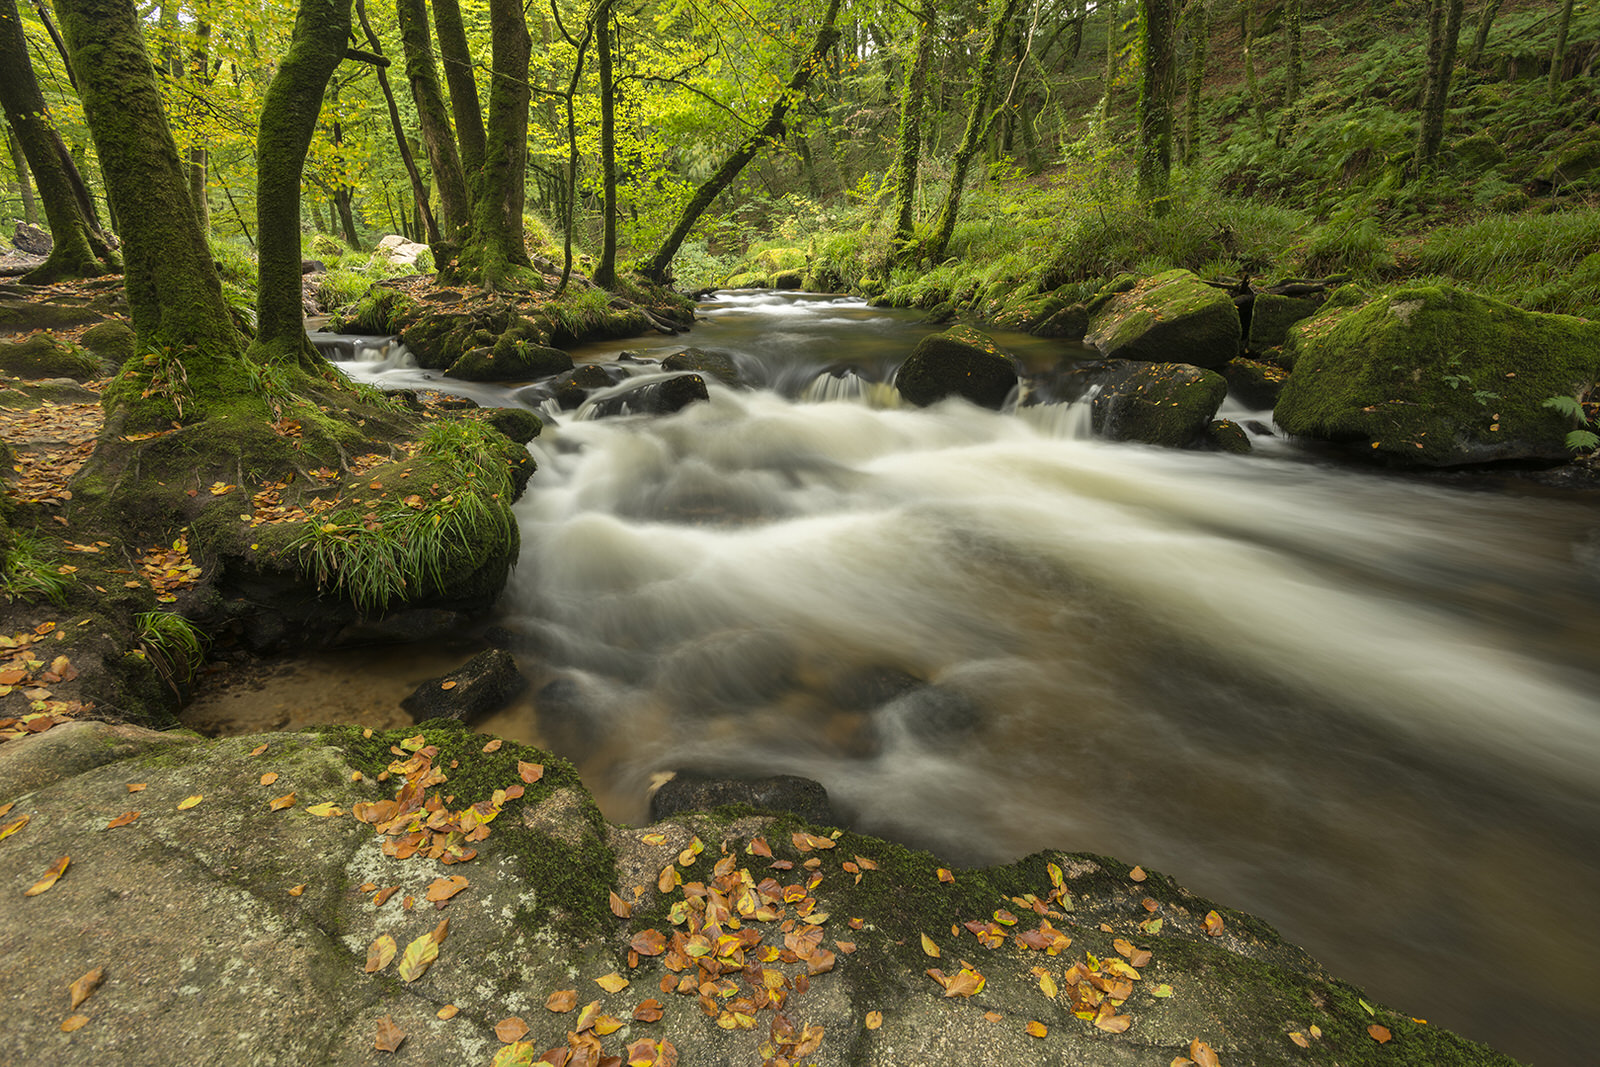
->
(56, 0), (235, 374)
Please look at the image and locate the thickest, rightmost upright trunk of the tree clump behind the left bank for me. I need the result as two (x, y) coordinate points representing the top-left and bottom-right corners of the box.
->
(451, 0), (533, 290)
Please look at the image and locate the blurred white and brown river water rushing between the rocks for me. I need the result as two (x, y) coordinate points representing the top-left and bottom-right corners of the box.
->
(315, 293), (1600, 1064)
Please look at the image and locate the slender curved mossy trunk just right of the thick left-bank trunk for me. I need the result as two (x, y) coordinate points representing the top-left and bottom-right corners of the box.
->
(253, 0), (355, 363)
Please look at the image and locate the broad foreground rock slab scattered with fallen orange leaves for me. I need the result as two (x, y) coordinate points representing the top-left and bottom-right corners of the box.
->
(0, 723), (1514, 1067)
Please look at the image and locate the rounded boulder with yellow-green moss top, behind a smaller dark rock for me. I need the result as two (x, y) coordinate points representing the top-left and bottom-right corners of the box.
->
(1083, 270), (1240, 366)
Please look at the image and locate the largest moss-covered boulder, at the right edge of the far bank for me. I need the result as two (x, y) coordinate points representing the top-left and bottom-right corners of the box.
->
(1274, 286), (1600, 467)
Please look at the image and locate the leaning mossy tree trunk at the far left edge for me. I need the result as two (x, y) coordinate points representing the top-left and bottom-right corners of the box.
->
(0, 0), (119, 285)
